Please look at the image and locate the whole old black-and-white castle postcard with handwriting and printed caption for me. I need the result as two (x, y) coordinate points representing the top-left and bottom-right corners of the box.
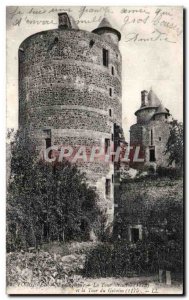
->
(6, 6), (184, 295)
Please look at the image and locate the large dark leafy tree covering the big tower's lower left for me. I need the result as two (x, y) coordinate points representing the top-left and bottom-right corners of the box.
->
(7, 131), (99, 250)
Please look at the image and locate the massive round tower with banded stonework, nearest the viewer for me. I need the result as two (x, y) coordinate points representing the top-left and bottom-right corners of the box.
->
(19, 13), (122, 227)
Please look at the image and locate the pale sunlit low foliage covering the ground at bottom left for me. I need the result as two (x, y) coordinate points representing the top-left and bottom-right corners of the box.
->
(7, 251), (85, 288)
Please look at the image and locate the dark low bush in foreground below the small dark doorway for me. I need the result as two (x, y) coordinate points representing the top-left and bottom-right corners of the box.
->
(84, 242), (159, 277)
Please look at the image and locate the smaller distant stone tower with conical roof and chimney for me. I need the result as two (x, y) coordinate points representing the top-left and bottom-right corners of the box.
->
(130, 89), (170, 168)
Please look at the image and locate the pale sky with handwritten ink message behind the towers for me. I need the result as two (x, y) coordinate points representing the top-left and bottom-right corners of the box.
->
(7, 6), (183, 141)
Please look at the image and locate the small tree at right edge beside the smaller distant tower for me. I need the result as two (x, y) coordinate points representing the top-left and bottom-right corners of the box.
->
(165, 120), (183, 169)
